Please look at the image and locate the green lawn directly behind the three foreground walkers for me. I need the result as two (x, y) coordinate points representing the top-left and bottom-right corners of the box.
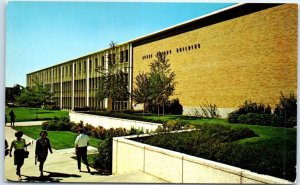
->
(15, 126), (99, 150)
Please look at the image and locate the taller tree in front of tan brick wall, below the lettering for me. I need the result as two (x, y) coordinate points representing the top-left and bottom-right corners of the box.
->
(149, 52), (176, 116)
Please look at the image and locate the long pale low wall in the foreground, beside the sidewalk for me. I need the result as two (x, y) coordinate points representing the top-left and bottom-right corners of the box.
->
(112, 136), (292, 184)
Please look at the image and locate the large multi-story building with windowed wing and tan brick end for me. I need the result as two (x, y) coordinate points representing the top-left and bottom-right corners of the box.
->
(27, 3), (298, 116)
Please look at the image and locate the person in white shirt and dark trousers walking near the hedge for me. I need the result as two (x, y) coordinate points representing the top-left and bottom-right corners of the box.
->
(75, 129), (91, 173)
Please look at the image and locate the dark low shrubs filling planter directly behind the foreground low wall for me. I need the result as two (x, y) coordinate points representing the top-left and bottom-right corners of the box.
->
(133, 124), (296, 181)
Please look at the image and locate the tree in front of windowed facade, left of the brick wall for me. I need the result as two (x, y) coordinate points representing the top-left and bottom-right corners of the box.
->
(96, 41), (129, 110)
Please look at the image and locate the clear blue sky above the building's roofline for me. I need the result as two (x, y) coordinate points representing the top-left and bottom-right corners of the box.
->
(5, 1), (234, 87)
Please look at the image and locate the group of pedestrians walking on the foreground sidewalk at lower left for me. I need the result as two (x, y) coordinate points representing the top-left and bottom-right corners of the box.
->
(5, 129), (90, 180)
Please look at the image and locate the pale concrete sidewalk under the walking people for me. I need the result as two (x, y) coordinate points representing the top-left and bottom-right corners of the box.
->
(4, 122), (167, 183)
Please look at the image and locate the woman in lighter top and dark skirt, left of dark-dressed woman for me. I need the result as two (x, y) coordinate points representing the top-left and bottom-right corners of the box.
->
(9, 131), (31, 180)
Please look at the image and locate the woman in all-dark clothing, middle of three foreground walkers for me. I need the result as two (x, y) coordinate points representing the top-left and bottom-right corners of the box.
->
(35, 130), (52, 177)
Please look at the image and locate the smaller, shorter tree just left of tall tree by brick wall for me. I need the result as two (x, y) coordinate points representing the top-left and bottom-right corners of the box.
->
(132, 73), (152, 114)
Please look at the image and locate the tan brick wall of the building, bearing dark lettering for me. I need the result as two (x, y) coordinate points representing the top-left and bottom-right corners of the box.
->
(133, 4), (298, 108)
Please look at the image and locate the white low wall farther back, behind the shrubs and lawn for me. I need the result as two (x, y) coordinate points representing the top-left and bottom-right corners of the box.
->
(69, 112), (162, 132)
